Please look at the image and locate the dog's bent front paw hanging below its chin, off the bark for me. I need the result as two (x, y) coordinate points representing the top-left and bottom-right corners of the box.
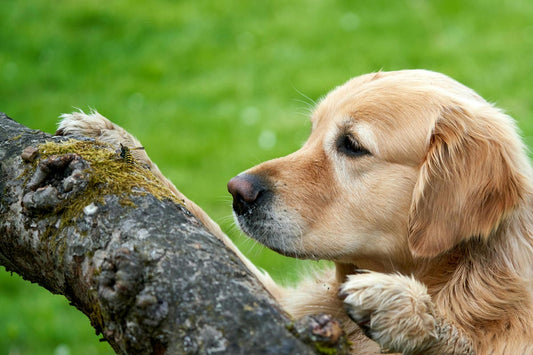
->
(340, 272), (436, 354)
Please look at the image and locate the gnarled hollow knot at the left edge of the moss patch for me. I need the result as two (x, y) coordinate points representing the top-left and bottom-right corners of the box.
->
(22, 148), (89, 213)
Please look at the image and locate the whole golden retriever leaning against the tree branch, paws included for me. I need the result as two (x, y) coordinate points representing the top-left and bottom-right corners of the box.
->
(59, 70), (533, 354)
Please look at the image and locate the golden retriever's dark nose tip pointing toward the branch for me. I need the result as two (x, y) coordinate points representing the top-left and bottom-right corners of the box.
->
(228, 174), (267, 215)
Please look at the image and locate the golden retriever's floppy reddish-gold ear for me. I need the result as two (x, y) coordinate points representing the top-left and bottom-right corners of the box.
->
(408, 106), (527, 257)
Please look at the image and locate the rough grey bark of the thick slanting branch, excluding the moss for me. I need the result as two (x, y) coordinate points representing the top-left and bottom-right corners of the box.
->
(0, 114), (345, 354)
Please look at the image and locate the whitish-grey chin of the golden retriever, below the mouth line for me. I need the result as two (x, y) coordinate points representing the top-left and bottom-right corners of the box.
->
(234, 213), (316, 259)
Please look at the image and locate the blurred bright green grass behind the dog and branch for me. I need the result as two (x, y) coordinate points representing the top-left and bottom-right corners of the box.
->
(0, 0), (533, 354)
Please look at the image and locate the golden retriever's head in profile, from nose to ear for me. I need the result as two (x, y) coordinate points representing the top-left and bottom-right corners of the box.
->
(228, 70), (529, 263)
